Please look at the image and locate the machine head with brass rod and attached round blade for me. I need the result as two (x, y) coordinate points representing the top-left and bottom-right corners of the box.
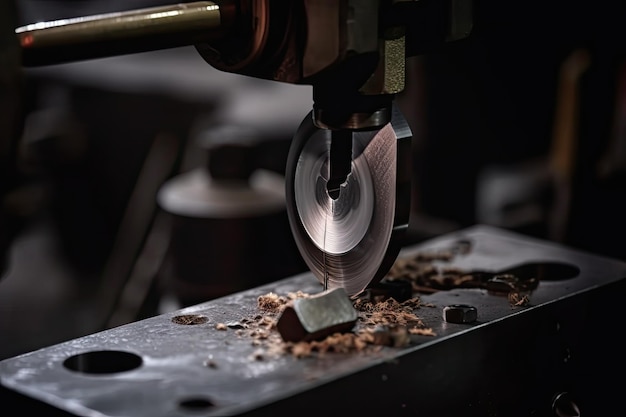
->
(11, 1), (472, 296)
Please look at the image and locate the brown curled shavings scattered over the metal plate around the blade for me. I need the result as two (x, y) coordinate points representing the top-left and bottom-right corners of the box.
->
(224, 240), (529, 360)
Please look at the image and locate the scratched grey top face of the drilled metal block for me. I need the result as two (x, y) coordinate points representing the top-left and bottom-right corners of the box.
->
(0, 226), (626, 417)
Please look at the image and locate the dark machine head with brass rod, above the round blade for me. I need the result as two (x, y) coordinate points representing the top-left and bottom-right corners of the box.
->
(16, 0), (471, 131)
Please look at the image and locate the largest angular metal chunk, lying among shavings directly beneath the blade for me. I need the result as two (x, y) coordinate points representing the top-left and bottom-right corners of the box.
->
(276, 288), (358, 342)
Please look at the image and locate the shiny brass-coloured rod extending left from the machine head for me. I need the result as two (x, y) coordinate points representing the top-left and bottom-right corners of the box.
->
(15, 1), (235, 67)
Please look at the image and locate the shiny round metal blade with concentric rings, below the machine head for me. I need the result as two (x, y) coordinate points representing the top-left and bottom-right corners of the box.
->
(286, 107), (410, 297)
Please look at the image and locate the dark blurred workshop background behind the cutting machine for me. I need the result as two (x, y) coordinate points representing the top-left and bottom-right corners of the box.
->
(0, 0), (626, 359)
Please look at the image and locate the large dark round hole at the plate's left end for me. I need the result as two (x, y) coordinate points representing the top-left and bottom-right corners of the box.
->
(63, 350), (143, 374)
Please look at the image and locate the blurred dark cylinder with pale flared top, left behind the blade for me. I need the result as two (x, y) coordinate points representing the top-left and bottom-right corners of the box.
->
(158, 126), (305, 306)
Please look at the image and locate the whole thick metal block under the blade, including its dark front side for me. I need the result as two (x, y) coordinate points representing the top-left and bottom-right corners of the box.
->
(0, 226), (626, 417)
